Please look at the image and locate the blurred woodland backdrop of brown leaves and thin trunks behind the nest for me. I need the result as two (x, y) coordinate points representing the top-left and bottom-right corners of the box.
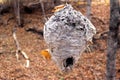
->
(0, 0), (120, 80)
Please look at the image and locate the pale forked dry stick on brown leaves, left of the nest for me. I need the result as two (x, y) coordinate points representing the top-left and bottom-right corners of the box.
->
(13, 29), (30, 67)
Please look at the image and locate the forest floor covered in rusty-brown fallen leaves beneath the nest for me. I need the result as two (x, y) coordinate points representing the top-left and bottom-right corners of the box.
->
(0, 5), (120, 80)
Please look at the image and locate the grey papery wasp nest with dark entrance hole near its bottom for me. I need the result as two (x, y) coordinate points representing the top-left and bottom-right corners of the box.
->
(44, 4), (96, 71)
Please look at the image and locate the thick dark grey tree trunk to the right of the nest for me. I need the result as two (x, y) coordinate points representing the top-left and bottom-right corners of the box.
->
(106, 0), (120, 80)
